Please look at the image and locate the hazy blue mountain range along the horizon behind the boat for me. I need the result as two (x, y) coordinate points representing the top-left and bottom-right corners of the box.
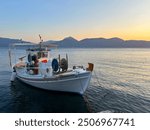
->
(0, 37), (150, 48)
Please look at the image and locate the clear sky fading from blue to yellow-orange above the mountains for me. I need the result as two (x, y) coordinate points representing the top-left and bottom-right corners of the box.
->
(0, 0), (150, 42)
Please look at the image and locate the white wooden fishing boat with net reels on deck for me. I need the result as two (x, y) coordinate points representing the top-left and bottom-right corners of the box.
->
(9, 36), (94, 95)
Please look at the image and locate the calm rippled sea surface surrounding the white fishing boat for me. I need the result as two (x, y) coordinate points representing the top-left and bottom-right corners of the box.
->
(0, 48), (150, 113)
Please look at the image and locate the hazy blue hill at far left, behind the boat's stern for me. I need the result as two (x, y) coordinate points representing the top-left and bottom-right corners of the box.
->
(0, 37), (28, 47)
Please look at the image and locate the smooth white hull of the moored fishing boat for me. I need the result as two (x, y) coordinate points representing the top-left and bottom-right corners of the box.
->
(17, 72), (91, 95)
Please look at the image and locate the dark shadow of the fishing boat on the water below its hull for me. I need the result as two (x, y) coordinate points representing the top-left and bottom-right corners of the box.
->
(9, 79), (89, 113)
